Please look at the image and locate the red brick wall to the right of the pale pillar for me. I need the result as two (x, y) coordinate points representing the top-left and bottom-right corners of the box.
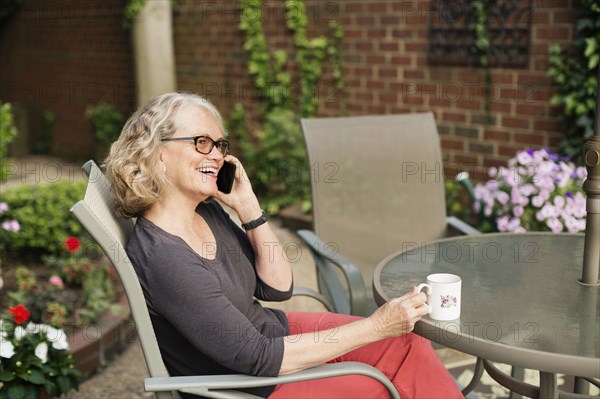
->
(175, 0), (575, 177)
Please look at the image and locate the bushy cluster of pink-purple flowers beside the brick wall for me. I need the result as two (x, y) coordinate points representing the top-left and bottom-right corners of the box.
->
(474, 149), (587, 233)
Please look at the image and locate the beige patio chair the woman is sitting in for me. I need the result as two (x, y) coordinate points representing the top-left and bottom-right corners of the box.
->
(71, 161), (399, 399)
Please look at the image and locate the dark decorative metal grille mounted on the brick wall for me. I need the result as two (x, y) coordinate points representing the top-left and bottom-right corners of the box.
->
(428, 0), (533, 67)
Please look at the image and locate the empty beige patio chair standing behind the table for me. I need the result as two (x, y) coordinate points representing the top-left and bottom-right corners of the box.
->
(298, 113), (479, 316)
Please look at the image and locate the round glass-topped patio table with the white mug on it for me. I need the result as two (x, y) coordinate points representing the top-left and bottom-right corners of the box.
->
(373, 233), (600, 398)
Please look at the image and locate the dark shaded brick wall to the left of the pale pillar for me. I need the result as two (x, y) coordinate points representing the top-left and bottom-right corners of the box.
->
(0, 0), (135, 160)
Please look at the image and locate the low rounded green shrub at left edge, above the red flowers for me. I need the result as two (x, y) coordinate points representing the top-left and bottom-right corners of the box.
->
(0, 180), (86, 256)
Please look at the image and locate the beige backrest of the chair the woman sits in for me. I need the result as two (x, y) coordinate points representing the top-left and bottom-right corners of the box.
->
(71, 161), (172, 398)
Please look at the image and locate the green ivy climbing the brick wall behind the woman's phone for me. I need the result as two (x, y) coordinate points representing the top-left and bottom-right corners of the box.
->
(233, 0), (346, 213)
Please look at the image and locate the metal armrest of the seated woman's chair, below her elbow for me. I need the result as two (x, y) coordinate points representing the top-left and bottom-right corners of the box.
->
(144, 362), (400, 398)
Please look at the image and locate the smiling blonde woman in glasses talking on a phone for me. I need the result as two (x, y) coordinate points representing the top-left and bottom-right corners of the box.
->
(106, 93), (462, 398)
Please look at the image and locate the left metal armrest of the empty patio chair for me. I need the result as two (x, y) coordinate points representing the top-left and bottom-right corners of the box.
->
(296, 230), (369, 316)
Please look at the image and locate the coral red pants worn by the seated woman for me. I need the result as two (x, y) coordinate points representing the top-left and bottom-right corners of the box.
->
(269, 312), (463, 399)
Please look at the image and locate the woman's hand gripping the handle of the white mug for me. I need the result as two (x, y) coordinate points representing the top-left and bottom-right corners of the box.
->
(369, 287), (429, 339)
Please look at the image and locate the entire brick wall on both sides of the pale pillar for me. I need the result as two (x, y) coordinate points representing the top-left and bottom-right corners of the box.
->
(0, 0), (575, 176)
